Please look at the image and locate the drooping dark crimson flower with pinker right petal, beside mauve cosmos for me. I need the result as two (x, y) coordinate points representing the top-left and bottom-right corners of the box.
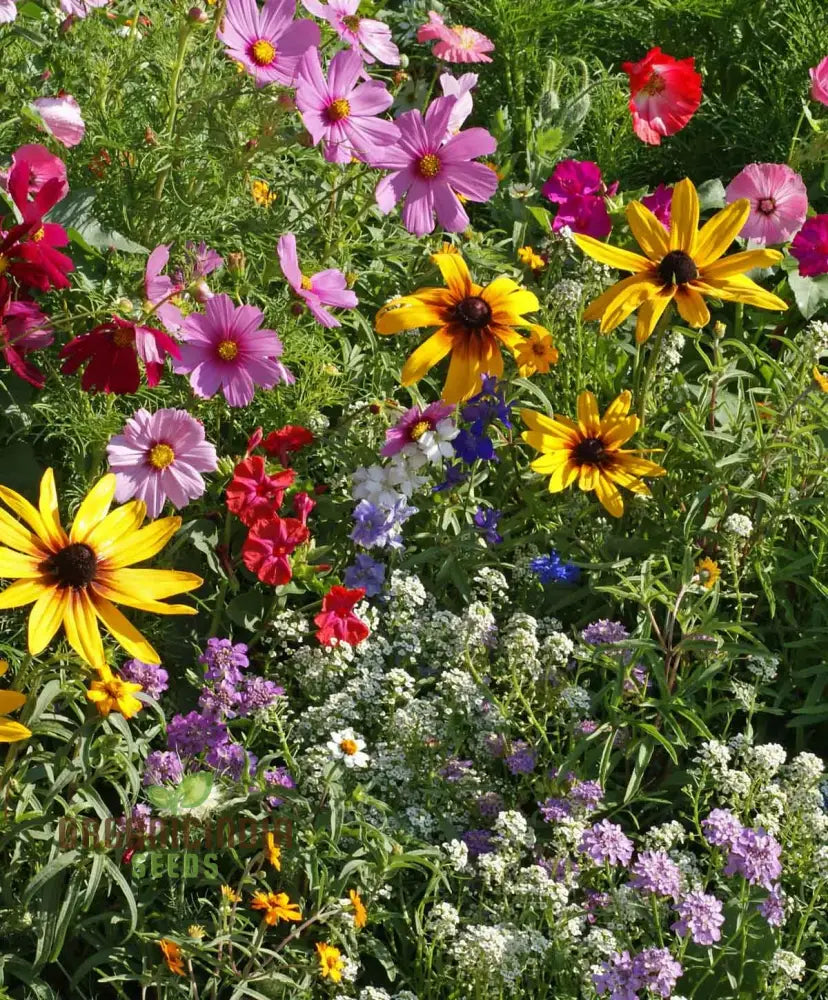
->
(58, 316), (180, 394)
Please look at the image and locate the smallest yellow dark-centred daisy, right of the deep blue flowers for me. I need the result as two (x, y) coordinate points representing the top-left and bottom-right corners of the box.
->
(520, 390), (667, 517)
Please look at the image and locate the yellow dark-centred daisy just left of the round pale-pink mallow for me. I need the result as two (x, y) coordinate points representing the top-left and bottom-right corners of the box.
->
(573, 178), (788, 343)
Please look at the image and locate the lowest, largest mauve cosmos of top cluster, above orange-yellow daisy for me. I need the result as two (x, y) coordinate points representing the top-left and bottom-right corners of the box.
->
(374, 97), (497, 236)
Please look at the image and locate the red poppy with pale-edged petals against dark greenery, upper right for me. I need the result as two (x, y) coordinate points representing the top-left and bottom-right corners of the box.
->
(621, 46), (701, 146)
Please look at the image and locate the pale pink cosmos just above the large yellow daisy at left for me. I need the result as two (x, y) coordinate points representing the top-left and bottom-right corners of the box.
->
(106, 409), (218, 518)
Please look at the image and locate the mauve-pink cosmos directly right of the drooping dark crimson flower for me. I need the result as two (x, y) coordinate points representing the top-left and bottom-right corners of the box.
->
(173, 295), (294, 406)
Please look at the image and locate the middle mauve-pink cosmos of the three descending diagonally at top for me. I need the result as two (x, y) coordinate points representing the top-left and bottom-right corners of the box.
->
(296, 48), (400, 164)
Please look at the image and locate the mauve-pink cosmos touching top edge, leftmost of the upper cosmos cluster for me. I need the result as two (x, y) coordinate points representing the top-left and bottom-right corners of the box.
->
(218, 0), (319, 87)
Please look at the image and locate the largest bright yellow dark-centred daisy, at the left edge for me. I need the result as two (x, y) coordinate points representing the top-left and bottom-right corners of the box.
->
(0, 469), (203, 670)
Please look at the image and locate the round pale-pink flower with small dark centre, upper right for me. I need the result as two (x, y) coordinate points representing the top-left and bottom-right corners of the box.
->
(725, 163), (808, 245)
